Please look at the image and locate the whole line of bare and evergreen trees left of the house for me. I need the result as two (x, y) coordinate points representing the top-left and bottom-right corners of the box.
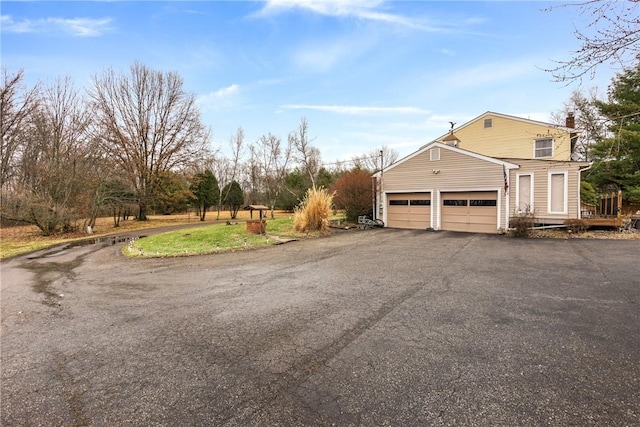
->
(0, 63), (398, 234)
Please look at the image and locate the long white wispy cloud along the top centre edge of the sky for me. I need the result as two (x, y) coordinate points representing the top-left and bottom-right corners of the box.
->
(255, 0), (451, 32)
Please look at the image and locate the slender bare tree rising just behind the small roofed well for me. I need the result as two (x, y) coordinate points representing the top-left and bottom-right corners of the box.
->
(250, 133), (291, 218)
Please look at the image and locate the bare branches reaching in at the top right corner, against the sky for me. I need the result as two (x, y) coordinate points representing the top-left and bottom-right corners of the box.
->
(545, 0), (640, 83)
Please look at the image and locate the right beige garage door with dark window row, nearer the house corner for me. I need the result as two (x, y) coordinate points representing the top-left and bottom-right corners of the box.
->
(441, 191), (498, 233)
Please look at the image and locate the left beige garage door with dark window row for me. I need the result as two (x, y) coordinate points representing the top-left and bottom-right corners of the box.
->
(387, 193), (431, 229)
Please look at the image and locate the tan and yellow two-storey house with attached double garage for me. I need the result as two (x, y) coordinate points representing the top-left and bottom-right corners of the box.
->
(375, 112), (588, 233)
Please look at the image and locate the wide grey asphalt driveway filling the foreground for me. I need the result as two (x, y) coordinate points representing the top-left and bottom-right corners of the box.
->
(1, 229), (640, 426)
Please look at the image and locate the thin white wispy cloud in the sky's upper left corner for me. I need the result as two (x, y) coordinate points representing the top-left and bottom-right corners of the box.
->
(0, 15), (113, 37)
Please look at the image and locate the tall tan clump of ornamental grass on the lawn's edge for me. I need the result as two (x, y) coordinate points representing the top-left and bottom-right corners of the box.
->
(293, 188), (333, 233)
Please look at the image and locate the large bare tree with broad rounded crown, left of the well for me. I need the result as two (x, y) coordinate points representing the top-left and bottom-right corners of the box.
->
(90, 63), (209, 220)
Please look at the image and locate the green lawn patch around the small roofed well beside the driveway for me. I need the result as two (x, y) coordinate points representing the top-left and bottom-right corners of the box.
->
(122, 218), (306, 258)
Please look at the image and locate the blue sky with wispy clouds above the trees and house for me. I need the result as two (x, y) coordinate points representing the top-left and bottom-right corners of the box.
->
(0, 0), (616, 163)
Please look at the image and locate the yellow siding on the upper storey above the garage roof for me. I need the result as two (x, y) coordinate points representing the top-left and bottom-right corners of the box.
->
(455, 115), (571, 161)
